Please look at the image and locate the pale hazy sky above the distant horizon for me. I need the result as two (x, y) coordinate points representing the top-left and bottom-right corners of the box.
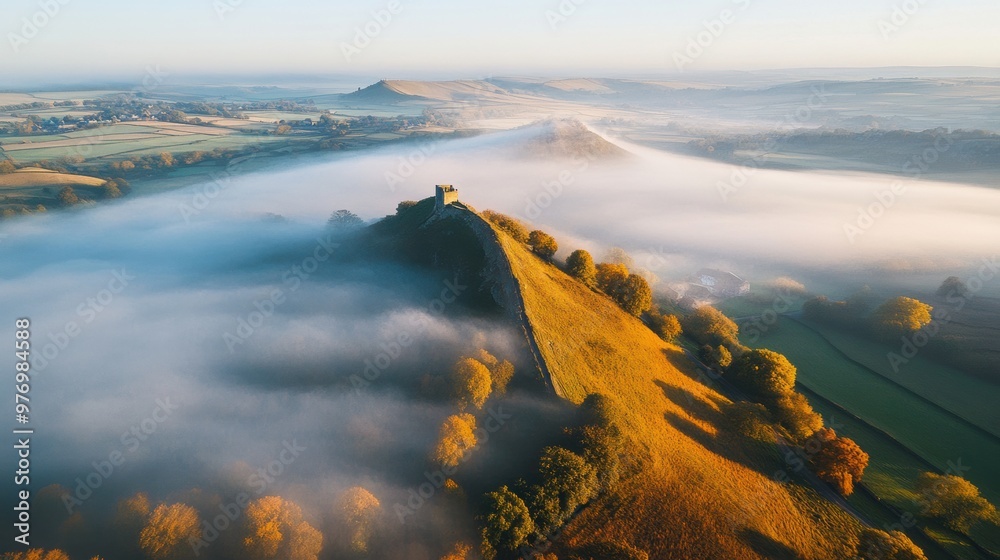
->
(0, 0), (1000, 82)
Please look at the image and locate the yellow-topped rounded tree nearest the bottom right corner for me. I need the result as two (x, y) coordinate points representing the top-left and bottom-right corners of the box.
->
(917, 472), (996, 534)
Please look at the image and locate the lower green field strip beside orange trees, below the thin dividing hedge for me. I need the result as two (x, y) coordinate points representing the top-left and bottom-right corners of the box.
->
(756, 317), (1000, 557)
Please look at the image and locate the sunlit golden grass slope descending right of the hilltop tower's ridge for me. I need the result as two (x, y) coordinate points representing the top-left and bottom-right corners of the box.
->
(488, 223), (860, 559)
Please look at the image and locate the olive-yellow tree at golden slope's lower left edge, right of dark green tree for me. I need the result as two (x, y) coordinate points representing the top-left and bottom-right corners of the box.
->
(530, 447), (600, 535)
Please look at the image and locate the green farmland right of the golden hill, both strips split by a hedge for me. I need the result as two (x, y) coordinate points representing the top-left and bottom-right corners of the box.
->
(755, 317), (1000, 558)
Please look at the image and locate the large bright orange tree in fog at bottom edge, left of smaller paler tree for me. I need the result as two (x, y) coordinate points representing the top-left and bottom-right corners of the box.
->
(243, 496), (323, 560)
